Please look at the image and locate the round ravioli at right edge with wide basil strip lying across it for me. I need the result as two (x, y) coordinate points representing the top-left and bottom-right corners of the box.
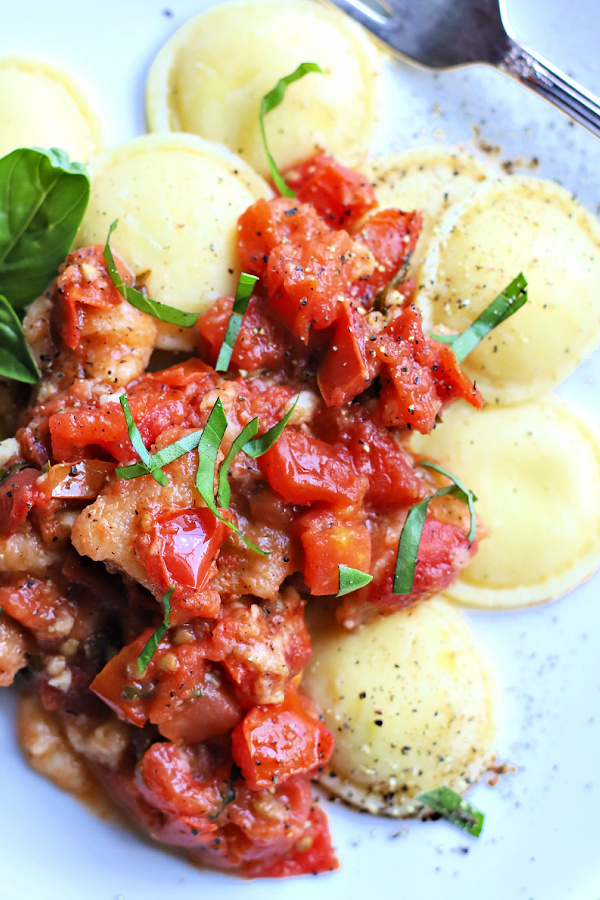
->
(417, 177), (600, 403)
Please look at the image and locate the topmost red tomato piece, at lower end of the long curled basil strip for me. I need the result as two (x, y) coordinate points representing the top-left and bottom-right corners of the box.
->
(284, 153), (377, 229)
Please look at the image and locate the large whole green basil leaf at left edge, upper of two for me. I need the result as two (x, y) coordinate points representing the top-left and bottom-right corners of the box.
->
(0, 147), (90, 306)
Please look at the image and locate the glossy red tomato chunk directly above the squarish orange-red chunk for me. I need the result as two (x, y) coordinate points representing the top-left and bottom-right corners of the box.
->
(260, 428), (366, 507)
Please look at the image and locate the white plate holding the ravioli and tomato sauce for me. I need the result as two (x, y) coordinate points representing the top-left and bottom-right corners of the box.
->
(0, 0), (600, 900)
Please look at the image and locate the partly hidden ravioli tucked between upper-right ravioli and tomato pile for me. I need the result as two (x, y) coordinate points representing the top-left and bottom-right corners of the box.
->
(364, 146), (499, 268)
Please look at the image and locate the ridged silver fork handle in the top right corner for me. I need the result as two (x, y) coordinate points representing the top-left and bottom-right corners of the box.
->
(498, 40), (600, 137)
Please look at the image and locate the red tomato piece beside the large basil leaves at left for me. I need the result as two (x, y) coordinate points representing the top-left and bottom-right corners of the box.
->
(53, 245), (133, 350)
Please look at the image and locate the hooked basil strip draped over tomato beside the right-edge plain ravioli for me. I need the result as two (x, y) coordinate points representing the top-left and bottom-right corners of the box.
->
(393, 462), (477, 594)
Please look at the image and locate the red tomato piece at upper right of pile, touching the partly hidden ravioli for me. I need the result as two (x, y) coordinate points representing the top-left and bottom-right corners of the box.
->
(355, 209), (423, 299)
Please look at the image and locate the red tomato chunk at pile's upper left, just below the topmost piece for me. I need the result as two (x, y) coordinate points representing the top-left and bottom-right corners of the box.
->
(238, 197), (331, 278)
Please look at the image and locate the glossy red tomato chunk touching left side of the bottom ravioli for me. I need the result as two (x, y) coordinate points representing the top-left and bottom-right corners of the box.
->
(232, 688), (333, 790)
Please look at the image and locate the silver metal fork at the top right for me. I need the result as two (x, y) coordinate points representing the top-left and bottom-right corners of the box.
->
(329, 0), (600, 137)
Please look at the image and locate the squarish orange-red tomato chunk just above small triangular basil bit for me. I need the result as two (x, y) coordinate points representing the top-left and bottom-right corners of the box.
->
(296, 510), (371, 596)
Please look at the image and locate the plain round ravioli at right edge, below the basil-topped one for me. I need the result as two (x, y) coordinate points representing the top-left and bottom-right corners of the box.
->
(413, 395), (600, 608)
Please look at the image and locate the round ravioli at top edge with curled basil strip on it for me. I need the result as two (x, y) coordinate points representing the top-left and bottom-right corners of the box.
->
(146, 0), (379, 176)
